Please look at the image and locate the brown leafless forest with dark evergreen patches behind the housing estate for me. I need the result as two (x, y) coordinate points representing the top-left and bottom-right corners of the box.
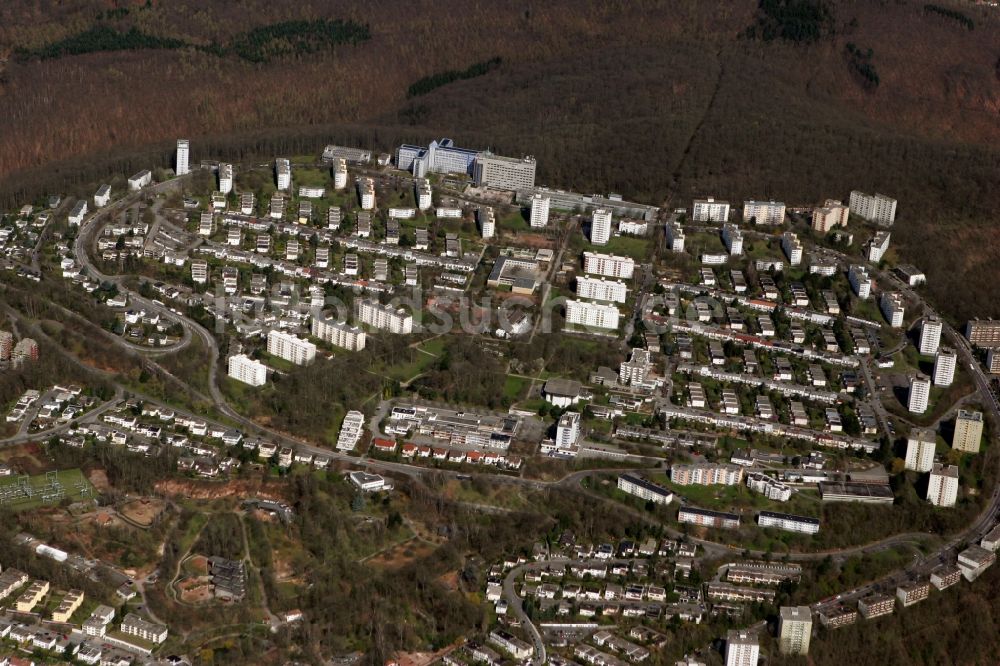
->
(0, 0), (1000, 320)
